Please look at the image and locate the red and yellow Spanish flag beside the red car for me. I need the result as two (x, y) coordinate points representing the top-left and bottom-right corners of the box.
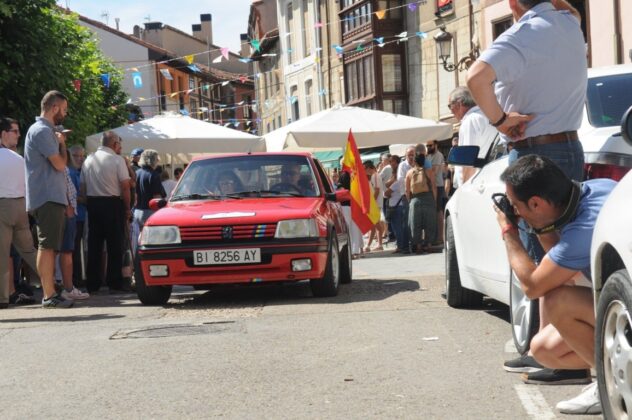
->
(342, 130), (380, 233)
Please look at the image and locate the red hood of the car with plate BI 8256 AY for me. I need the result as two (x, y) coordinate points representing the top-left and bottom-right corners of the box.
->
(146, 197), (323, 226)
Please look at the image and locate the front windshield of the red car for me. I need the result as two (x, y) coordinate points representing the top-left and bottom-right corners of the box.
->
(171, 155), (320, 201)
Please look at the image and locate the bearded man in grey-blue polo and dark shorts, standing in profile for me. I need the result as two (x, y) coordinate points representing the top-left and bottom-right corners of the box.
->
(24, 90), (73, 308)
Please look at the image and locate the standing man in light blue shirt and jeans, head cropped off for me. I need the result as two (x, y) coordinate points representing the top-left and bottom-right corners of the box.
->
(467, 0), (588, 384)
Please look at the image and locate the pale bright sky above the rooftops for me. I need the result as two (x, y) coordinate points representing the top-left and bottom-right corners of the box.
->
(57, 0), (252, 53)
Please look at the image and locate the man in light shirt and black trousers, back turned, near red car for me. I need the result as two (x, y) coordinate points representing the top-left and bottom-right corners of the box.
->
(81, 131), (131, 293)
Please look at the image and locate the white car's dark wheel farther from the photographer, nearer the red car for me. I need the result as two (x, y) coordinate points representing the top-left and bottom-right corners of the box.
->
(445, 216), (483, 308)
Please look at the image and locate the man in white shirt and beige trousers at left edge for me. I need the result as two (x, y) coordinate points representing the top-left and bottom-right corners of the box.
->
(0, 118), (37, 309)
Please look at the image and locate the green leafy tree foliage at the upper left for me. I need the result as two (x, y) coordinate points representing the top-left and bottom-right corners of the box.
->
(0, 0), (127, 143)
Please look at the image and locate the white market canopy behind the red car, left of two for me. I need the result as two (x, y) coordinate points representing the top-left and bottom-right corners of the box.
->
(86, 113), (265, 164)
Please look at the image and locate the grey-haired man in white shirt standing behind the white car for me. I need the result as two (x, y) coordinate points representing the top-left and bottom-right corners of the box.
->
(448, 86), (498, 187)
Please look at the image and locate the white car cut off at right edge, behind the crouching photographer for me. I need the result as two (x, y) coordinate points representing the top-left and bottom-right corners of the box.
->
(591, 108), (632, 419)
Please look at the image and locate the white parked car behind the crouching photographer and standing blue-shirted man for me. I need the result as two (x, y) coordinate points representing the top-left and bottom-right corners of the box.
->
(444, 65), (632, 353)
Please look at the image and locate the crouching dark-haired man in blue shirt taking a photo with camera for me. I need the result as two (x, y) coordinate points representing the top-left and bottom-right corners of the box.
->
(493, 155), (616, 414)
